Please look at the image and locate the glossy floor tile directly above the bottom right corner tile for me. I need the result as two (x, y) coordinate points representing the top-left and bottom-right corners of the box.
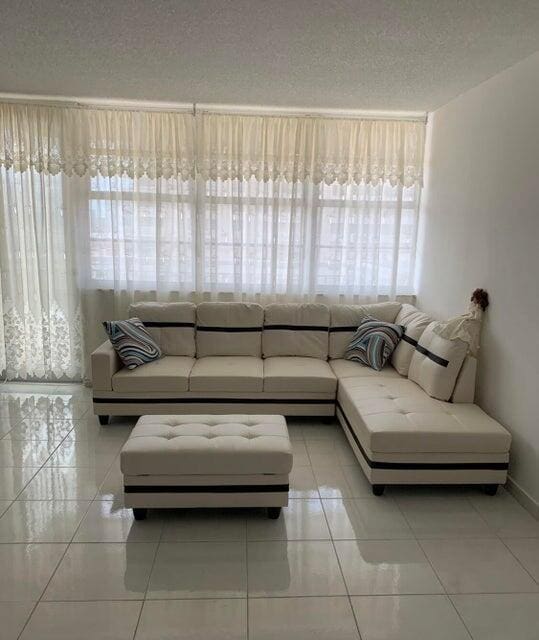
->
(420, 538), (539, 593)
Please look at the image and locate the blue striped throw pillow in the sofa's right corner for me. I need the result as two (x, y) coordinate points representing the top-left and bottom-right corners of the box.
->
(344, 316), (404, 371)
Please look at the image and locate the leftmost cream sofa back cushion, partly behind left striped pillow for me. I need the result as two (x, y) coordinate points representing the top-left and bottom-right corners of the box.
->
(129, 302), (196, 358)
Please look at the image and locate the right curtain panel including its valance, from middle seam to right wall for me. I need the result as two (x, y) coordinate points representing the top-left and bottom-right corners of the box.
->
(197, 114), (424, 300)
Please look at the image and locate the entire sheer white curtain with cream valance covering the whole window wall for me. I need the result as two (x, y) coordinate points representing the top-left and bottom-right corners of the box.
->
(0, 104), (424, 379)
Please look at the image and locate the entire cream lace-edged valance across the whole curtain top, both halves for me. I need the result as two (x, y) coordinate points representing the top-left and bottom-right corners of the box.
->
(0, 104), (425, 186)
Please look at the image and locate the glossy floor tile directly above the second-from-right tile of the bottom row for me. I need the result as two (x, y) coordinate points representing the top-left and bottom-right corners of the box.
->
(335, 540), (444, 595)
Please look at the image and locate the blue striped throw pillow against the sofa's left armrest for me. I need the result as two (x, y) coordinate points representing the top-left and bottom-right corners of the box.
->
(103, 318), (162, 369)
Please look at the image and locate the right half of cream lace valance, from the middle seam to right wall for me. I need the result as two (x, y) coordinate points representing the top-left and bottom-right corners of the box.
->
(197, 114), (425, 186)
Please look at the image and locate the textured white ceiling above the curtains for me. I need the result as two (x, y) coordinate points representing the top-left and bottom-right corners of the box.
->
(0, 0), (539, 110)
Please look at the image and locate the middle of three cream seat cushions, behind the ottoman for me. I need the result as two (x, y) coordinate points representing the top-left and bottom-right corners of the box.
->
(189, 356), (264, 393)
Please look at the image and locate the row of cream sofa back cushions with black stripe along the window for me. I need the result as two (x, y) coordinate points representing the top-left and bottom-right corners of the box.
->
(129, 302), (401, 360)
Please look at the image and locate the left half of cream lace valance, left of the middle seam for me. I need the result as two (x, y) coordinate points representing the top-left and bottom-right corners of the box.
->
(0, 104), (195, 179)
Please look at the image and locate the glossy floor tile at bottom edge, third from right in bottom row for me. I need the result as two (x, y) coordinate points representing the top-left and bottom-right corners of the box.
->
(249, 597), (360, 640)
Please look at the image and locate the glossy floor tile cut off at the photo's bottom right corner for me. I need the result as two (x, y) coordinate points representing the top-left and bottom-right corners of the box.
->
(451, 593), (539, 640)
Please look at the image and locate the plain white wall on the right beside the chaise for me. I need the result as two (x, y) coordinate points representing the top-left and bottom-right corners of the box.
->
(418, 53), (539, 510)
